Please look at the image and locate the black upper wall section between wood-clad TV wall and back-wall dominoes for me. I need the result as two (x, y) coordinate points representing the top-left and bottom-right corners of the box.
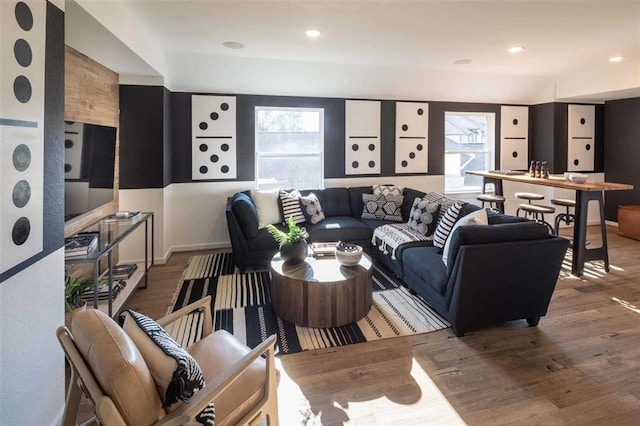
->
(120, 85), (164, 189)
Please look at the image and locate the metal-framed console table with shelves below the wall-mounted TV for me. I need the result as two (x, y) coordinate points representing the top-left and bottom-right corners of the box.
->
(65, 212), (154, 317)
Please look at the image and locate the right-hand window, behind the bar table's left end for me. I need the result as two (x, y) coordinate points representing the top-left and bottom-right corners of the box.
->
(444, 112), (495, 193)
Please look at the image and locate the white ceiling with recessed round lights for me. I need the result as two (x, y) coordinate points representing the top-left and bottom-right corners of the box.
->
(67, 0), (640, 102)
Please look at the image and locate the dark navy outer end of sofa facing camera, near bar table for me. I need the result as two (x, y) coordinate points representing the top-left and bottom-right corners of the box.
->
(445, 237), (569, 335)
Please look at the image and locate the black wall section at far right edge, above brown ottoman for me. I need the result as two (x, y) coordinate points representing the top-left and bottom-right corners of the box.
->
(604, 98), (640, 221)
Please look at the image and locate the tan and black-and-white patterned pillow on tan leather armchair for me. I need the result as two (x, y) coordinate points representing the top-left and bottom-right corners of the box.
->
(123, 310), (215, 425)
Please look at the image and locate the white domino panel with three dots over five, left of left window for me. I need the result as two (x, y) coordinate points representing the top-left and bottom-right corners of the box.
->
(191, 95), (237, 180)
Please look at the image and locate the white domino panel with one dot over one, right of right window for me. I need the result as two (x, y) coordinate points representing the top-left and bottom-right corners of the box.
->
(499, 106), (529, 170)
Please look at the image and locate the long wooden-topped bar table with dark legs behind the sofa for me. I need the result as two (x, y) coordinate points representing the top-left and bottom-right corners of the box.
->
(466, 171), (633, 276)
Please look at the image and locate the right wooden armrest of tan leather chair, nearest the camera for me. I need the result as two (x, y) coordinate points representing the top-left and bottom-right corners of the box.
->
(156, 334), (277, 426)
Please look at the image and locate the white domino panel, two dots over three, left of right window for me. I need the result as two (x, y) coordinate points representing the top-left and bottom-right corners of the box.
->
(396, 102), (429, 173)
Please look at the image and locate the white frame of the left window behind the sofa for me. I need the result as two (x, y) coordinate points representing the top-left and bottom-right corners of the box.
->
(254, 106), (324, 190)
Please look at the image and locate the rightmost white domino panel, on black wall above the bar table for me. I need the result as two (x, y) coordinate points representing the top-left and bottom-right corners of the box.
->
(567, 105), (596, 172)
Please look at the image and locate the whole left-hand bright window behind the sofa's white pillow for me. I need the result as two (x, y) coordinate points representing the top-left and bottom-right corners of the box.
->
(256, 107), (324, 189)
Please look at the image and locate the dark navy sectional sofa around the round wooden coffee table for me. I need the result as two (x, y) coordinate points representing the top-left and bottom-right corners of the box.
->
(226, 186), (569, 336)
